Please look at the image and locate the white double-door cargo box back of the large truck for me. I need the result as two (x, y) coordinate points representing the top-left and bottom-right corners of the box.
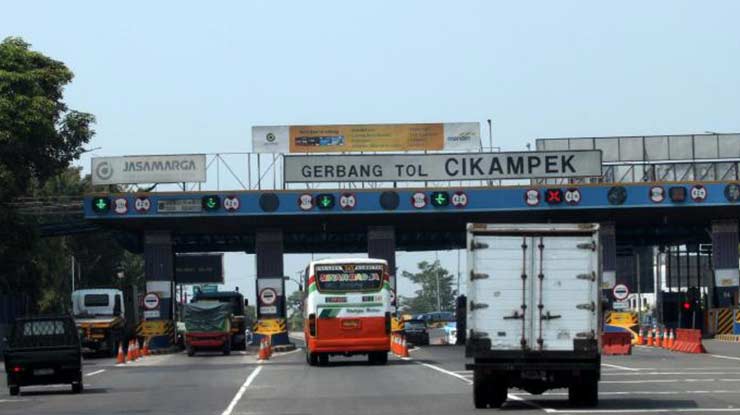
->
(467, 225), (600, 350)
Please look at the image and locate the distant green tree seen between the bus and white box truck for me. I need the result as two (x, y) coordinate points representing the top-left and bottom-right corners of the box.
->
(401, 261), (457, 313)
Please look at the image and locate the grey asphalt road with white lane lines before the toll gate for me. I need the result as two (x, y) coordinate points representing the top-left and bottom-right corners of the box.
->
(0, 342), (740, 415)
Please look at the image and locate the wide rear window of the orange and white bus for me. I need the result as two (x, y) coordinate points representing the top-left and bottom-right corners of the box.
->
(315, 264), (383, 292)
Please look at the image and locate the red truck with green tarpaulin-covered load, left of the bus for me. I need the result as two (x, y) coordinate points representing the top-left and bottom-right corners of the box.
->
(182, 302), (232, 356)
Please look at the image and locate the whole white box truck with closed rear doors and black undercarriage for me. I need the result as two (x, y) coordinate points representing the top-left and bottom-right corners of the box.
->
(465, 224), (601, 408)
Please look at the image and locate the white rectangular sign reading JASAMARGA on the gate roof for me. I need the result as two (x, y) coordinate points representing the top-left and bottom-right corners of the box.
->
(92, 154), (206, 186)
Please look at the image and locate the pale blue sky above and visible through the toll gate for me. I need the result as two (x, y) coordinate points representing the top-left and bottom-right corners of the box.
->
(0, 0), (740, 308)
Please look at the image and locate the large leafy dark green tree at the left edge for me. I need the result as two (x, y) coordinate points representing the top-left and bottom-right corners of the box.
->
(0, 37), (94, 305)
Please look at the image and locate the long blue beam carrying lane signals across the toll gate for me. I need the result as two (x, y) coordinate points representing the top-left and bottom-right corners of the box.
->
(84, 182), (740, 220)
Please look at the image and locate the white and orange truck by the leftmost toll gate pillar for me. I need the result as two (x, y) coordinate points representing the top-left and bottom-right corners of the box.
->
(72, 288), (126, 356)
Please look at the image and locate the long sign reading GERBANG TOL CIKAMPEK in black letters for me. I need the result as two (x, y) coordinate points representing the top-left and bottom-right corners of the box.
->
(284, 150), (602, 183)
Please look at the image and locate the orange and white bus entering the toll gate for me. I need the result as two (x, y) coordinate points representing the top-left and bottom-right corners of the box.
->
(303, 258), (392, 366)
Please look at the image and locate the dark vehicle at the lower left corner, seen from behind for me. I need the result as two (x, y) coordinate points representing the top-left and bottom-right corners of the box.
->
(4, 316), (82, 395)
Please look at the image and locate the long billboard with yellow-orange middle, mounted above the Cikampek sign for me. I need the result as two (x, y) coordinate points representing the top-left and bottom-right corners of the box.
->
(252, 122), (480, 153)
